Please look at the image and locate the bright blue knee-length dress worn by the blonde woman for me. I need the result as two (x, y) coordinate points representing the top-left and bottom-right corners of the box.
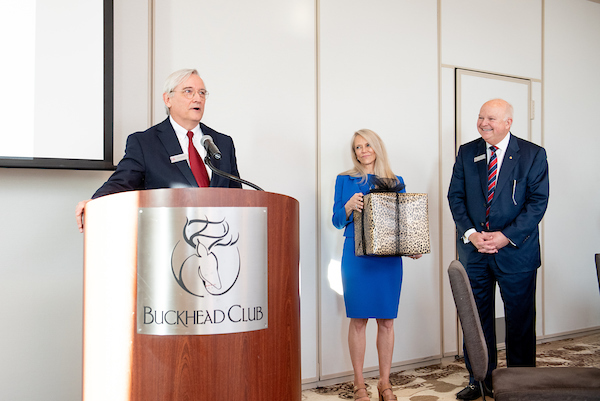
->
(332, 175), (405, 319)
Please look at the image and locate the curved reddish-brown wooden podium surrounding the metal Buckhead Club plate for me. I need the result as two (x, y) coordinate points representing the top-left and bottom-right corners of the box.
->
(83, 188), (301, 401)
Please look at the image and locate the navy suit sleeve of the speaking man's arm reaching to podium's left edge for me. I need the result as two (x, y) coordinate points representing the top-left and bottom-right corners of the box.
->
(92, 134), (146, 199)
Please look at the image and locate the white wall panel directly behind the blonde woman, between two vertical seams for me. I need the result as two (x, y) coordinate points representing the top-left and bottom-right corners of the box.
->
(319, 0), (440, 378)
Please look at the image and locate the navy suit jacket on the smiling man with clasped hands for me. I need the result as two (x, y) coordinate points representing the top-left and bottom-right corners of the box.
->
(448, 134), (549, 273)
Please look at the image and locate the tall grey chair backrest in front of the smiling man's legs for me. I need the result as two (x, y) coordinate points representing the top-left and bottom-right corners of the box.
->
(448, 260), (488, 401)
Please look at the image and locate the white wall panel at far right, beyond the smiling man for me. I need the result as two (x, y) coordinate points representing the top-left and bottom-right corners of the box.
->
(544, 0), (600, 334)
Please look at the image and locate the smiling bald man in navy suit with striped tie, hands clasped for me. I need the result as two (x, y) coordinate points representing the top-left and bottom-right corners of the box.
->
(448, 99), (549, 400)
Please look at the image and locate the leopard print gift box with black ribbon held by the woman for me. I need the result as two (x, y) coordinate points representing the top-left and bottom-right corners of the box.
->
(354, 192), (431, 256)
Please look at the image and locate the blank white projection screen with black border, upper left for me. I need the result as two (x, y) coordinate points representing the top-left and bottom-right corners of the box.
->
(0, 0), (114, 170)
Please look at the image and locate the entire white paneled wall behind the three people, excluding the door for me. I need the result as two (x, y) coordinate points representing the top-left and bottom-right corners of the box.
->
(0, 0), (600, 401)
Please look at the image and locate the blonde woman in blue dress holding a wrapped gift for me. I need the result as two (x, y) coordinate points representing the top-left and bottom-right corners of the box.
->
(332, 129), (421, 401)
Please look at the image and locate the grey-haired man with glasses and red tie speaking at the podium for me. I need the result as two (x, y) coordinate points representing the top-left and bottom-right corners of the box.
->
(75, 69), (241, 232)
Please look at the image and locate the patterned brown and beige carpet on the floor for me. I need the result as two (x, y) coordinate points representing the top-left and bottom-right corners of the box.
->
(302, 333), (600, 401)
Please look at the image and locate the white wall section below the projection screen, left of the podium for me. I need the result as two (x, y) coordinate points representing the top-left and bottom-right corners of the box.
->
(0, 169), (106, 400)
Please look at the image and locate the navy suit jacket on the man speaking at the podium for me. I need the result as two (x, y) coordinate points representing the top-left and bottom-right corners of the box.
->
(92, 118), (242, 199)
